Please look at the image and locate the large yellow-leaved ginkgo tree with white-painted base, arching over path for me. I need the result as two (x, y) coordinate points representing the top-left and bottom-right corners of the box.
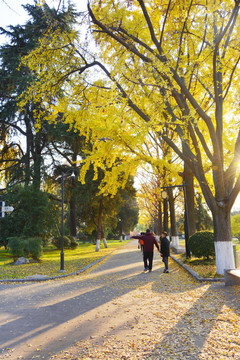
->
(20, 0), (240, 274)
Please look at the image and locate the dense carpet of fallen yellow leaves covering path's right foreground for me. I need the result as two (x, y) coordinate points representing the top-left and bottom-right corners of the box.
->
(52, 261), (240, 360)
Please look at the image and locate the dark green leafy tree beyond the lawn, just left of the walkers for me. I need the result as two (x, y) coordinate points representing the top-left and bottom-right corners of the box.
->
(74, 166), (138, 246)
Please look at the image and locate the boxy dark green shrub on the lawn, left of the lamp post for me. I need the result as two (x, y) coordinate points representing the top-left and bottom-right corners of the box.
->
(8, 237), (42, 261)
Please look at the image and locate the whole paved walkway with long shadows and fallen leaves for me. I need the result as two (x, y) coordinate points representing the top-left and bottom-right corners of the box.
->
(0, 240), (240, 360)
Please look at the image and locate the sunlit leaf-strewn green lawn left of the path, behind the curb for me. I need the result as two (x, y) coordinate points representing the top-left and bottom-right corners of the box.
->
(0, 240), (126, 279)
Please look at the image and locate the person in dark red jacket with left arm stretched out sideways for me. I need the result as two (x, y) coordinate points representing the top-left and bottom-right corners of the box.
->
(131, 229), (160, 272)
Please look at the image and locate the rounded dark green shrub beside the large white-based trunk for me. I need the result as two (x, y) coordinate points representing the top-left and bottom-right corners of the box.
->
(188, 231), (215, 259)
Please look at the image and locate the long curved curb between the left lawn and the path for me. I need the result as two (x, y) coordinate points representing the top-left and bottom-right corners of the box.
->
(0, 244), (126, 284)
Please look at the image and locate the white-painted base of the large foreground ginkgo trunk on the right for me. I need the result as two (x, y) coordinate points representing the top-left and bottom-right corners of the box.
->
(214, 241), (235, 275)
